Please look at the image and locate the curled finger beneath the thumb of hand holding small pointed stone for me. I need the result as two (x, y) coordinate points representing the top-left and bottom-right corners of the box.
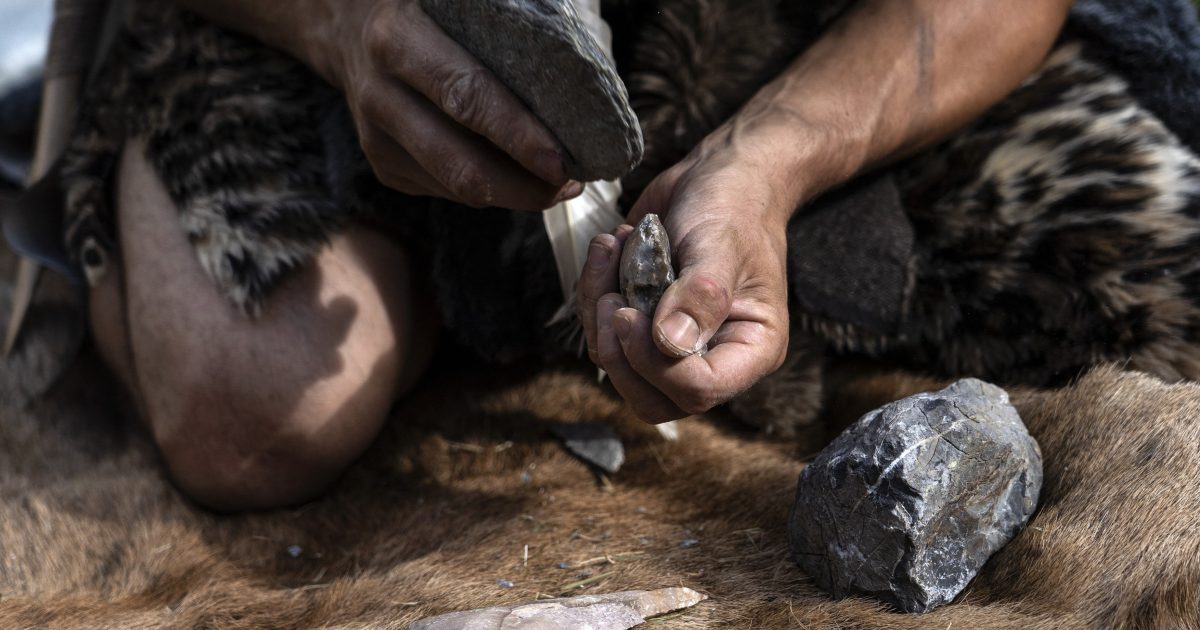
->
(613, 308), (786, 414)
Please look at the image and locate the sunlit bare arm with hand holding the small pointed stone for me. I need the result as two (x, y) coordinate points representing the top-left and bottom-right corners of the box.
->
(578, 0), (1070, 421)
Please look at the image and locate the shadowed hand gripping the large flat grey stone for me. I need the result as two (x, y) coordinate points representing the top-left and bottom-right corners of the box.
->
(307, 0), (583, 210)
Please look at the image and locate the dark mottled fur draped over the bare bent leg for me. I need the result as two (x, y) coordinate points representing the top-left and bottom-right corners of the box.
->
(62, 7), (353, 313)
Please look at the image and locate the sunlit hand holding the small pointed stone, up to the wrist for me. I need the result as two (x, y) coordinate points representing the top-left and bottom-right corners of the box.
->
(576, 137), (794, 422)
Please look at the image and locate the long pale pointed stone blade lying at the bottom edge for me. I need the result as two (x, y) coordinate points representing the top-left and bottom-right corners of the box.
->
(412, 587), (708, 630)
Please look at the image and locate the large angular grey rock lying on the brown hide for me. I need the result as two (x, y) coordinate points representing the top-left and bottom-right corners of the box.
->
(788, 378), (1042, 612)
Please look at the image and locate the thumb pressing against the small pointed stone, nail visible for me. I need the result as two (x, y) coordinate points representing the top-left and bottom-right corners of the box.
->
(654, 265), (734, 359)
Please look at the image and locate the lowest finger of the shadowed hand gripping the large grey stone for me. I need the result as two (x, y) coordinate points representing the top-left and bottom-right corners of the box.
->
(360, 84), (583, 210)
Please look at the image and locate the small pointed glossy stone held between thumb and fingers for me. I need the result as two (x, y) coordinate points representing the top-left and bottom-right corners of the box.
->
(620, 214), (676, 317)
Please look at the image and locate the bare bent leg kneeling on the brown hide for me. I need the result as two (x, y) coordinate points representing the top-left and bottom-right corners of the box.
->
(91, 143), (428, 510)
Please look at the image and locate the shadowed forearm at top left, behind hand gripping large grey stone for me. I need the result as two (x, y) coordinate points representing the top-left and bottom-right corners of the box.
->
(175, 0), (343, 84)
